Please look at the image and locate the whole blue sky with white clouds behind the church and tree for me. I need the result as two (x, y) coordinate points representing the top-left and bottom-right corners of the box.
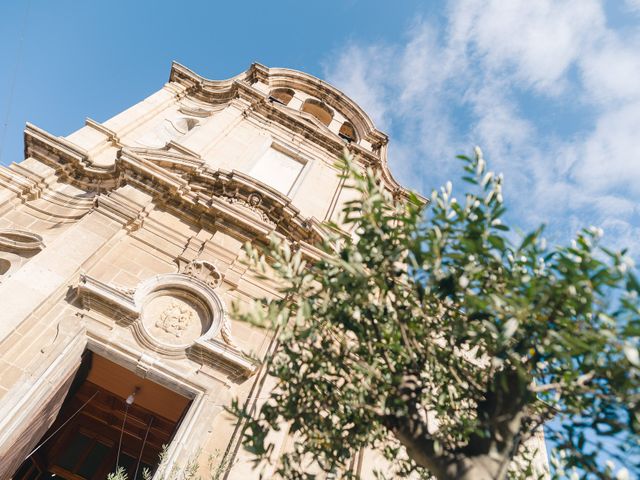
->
(0, 0), (640, 474)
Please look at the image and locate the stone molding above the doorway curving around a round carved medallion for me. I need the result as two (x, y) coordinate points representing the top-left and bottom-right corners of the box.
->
(76, 272), (258, 378)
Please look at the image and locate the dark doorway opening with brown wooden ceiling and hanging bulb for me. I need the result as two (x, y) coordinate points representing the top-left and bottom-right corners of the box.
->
(13, 351), (190, 480)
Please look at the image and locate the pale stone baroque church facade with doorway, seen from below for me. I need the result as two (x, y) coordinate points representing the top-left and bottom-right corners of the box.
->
(0, 64), (410, 480)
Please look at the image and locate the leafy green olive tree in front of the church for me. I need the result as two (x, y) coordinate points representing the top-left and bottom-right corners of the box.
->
(231, 148), (640, 480)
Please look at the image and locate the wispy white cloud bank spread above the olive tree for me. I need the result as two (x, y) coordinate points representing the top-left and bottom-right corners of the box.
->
(325, 0), (640, 254)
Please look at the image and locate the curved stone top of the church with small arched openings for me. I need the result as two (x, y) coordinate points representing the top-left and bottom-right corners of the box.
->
(170, 62), (408, 201)
